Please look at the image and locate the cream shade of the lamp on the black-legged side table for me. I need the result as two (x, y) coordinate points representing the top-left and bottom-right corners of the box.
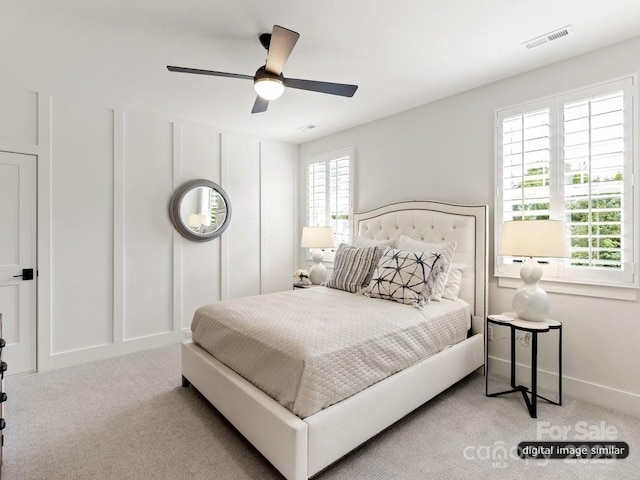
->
(499, 220), (569, 258)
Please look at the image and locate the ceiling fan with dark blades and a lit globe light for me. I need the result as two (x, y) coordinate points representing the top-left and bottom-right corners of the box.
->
(167, 25), (358, 113)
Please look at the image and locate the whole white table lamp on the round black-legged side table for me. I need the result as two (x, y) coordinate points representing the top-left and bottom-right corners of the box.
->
(499, 220), (569, 322)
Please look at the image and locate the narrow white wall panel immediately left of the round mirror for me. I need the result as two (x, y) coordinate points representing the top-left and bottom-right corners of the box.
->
(120, 113), (172, 341)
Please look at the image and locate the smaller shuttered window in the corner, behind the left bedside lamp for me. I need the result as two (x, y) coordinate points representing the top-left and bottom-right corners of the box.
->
(307, 150), (353, 245)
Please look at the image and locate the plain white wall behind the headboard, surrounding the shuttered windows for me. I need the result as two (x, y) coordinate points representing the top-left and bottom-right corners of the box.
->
(298, 37), (640, 414)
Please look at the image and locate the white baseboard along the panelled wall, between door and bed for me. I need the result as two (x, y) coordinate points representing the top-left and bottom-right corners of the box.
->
(48, 331), (184, 371)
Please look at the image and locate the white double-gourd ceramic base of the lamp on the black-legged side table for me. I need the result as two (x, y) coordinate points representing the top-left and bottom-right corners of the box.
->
(512, 258), (549, 322)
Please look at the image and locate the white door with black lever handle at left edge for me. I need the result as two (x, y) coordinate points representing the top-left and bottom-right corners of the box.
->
(0, 152), (37, 374)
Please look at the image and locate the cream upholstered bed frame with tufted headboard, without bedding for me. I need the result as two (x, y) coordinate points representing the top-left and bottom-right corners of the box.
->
(182, 202), (488, 480)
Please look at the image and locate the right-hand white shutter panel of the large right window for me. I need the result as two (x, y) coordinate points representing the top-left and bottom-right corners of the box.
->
(563, 91), (625, 269)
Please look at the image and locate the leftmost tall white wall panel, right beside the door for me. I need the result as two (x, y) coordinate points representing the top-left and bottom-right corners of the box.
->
(51, 97), (113, 354)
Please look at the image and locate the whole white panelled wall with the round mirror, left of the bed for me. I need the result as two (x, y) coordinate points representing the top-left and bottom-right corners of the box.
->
(0, 86), (298, 370)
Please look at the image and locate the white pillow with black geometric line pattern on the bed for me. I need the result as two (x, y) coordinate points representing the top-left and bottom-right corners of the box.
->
(365, 248), (442, 307)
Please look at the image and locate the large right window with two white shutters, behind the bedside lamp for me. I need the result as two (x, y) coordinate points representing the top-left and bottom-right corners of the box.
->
(495, 78), (637, 285)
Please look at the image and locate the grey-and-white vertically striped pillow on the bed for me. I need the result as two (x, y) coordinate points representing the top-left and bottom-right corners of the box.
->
(325, 243), (385, 293)
